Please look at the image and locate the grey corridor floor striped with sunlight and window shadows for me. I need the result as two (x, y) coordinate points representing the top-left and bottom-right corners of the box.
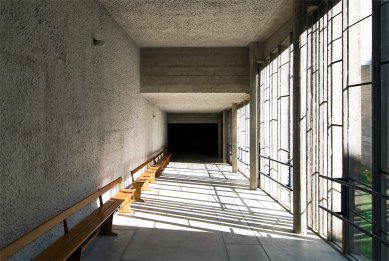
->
(83, 162), (345, 261)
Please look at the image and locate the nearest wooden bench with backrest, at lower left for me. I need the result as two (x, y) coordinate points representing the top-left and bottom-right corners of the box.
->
(0, 177), (126, 260)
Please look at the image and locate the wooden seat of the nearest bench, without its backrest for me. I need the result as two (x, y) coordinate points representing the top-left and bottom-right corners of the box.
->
(34, 199), (123, 260)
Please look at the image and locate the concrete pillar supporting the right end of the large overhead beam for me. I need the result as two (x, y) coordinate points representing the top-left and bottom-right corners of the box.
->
(249, 43), (258, 189)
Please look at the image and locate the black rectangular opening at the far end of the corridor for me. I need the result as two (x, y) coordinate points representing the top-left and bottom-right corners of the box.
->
(168, 123), (218, 159)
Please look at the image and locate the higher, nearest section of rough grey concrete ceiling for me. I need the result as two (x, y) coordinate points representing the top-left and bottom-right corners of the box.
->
(99, 0), (292, 47)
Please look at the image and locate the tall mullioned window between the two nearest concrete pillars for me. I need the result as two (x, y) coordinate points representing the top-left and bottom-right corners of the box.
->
(259, 37), (292, 209)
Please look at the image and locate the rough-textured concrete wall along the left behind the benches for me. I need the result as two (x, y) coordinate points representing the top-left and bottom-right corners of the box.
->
(0, 0), (167, 258)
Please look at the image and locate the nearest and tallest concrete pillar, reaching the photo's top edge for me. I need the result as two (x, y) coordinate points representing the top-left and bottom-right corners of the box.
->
(293, 0), (307, 234)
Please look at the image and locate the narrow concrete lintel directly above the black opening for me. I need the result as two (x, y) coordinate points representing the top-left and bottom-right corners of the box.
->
(167, 113), (219, 124)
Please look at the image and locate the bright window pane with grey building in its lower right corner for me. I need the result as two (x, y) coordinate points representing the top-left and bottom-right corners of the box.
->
(348, 17), (372, 85)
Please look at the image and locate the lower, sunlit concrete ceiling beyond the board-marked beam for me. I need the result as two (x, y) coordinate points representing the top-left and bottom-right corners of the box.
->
(142, 93), (250, 113)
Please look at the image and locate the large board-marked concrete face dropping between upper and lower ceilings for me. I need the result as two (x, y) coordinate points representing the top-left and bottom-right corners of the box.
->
(141, 47), (250, 93)
